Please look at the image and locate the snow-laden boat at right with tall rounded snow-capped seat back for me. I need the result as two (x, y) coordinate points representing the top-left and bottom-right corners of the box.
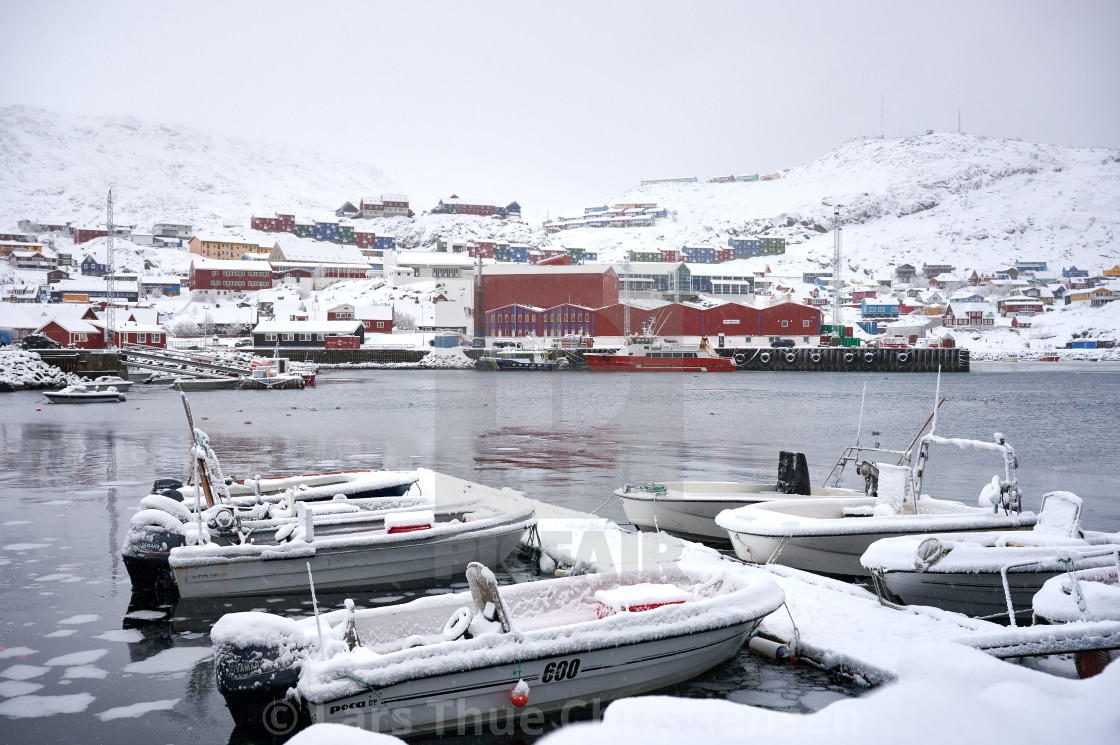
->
(860, 492), (1120, 624)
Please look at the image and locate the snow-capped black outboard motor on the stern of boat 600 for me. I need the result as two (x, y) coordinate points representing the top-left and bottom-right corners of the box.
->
(211, 612), (318, 727)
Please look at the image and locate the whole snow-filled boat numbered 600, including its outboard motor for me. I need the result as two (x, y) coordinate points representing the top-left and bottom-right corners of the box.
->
(211, 565), (784, 735)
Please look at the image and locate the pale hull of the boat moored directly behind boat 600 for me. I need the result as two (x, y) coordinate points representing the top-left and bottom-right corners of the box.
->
(171, 520), (533, 598)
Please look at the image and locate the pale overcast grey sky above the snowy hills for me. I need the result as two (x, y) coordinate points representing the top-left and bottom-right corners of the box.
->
(0, 0), (1120, 214)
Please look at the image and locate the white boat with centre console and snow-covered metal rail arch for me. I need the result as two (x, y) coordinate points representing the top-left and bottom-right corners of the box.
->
(716, 427), (1035, 577)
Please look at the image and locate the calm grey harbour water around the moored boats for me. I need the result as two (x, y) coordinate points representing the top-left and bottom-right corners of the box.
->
(0, 362), (1120, 743)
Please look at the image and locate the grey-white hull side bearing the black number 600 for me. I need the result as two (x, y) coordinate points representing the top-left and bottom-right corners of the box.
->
(309, 620), (758, 735)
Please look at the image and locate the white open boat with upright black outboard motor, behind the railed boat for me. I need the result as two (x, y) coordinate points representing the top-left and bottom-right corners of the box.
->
(615, 451), (865, 548)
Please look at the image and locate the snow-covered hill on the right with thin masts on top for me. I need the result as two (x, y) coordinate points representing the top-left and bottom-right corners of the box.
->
(550, 133), (1120, 276)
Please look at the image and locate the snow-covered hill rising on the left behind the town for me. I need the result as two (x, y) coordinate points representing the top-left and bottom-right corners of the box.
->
(0, 106), (396, 231)
